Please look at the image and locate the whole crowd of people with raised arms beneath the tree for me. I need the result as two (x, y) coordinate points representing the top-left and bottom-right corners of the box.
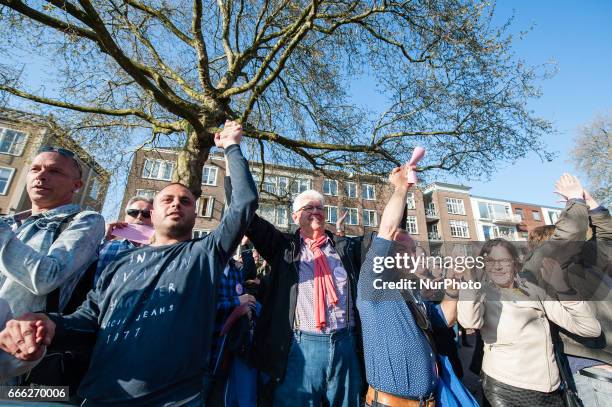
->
(0, 122), (612, 407)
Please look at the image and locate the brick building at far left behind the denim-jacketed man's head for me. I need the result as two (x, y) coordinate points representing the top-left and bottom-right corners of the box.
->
(0, 109), (109, 215)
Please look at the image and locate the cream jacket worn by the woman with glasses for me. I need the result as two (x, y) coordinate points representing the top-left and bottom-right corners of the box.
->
(457, 283), (601, 392)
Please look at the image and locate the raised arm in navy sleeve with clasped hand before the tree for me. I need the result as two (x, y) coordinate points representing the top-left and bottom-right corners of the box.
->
(211, 122), (258, 264)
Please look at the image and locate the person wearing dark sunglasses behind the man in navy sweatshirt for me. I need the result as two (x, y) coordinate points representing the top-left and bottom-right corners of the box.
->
(94, 196), (153, 284)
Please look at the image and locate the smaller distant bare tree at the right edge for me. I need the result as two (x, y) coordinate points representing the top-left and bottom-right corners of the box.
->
(571, 111), (612, 206)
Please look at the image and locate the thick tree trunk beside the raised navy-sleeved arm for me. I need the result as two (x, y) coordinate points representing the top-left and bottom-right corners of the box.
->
(172, 121), (214, 198)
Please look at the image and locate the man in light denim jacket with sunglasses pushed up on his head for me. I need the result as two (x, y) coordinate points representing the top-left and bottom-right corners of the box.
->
(0, 147), (104, 315)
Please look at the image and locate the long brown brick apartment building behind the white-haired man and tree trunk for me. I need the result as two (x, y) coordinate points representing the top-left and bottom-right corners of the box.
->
(121, 148), (426, 240)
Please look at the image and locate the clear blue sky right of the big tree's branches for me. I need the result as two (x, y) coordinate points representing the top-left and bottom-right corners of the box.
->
(448, 0), (612, 206)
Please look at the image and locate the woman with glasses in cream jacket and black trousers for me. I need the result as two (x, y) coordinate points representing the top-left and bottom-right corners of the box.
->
(457, 239), (601, 407)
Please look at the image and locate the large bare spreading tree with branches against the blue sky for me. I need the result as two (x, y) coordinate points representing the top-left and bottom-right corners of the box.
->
(0, 0), (551, 198)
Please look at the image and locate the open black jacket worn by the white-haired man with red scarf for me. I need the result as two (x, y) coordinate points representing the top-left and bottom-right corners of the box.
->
(225, 177), (361, 383)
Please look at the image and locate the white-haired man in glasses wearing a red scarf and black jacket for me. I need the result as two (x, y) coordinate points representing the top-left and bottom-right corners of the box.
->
(226, 179), (363, 407)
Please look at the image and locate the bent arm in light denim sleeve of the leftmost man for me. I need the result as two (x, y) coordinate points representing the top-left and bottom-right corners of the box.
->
(0, 212), (104, 295)
